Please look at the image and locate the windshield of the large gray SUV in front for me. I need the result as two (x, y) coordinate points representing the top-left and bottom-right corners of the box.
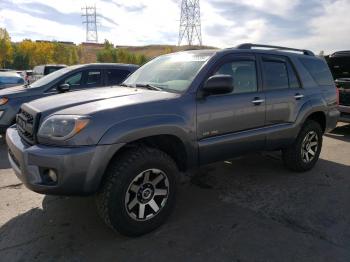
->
(124, 53), (212, 93)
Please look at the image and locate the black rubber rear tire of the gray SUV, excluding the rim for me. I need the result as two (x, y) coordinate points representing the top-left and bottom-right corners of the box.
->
(282, 120), (323, 172)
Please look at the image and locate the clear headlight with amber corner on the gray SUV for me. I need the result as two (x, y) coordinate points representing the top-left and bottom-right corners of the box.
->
(38, 115), (89, 140)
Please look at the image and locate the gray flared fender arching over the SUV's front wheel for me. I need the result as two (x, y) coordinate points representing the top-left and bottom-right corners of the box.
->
(98, 115), (198, 166)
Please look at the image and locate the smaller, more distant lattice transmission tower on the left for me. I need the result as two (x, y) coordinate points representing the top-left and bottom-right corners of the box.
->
(81, 6), (98, 43)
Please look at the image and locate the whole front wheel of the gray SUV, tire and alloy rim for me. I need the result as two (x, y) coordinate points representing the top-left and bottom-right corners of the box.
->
(96, 147), (178, 236)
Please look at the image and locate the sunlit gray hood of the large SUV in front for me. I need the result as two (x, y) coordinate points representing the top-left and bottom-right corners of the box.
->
(29, 87), (178, 114)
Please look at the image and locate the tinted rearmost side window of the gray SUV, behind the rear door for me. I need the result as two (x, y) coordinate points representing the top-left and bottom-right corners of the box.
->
(300, 58), (334, 86)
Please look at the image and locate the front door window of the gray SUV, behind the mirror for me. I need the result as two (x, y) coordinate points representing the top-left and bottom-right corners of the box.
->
(214, 61), (258, 94)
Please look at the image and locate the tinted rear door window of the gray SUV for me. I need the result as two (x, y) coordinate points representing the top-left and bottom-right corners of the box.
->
(262, 60), (289, 90)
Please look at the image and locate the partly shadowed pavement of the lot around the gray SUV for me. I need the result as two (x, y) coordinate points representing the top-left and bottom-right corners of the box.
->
(0, 124), (350, 262)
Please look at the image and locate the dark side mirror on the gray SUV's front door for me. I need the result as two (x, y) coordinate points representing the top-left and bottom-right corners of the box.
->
(202, 75), (233, 95)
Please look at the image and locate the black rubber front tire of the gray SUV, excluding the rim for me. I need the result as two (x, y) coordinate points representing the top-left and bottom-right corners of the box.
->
(96, 146), (178, 236)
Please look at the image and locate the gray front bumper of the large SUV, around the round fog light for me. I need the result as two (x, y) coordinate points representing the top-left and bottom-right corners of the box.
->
(6, 127), (123, 195)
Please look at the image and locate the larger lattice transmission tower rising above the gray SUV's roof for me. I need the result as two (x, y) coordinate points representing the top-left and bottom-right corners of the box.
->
(179, 0), (202, 46)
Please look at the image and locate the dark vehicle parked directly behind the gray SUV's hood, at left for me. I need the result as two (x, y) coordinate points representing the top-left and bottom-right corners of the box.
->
(0, 64), (138, 133)
